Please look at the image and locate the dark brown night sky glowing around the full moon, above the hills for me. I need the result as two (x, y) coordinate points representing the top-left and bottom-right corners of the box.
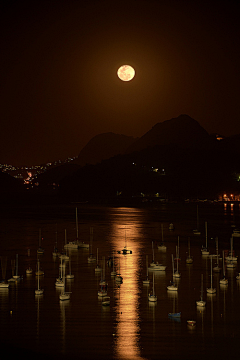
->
(0, 0), (240, 166)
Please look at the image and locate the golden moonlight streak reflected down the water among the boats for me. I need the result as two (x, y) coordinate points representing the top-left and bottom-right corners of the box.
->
(109, 208), (145, 360)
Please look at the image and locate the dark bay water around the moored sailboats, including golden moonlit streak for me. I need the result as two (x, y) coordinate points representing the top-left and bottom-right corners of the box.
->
(0, 203), (240, 360)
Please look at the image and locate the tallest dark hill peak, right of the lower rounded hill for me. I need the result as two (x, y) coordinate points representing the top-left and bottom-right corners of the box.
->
(126, 115), (210, 154)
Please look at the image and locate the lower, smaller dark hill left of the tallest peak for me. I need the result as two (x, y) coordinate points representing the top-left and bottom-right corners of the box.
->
(75, 132), (137, 166)
